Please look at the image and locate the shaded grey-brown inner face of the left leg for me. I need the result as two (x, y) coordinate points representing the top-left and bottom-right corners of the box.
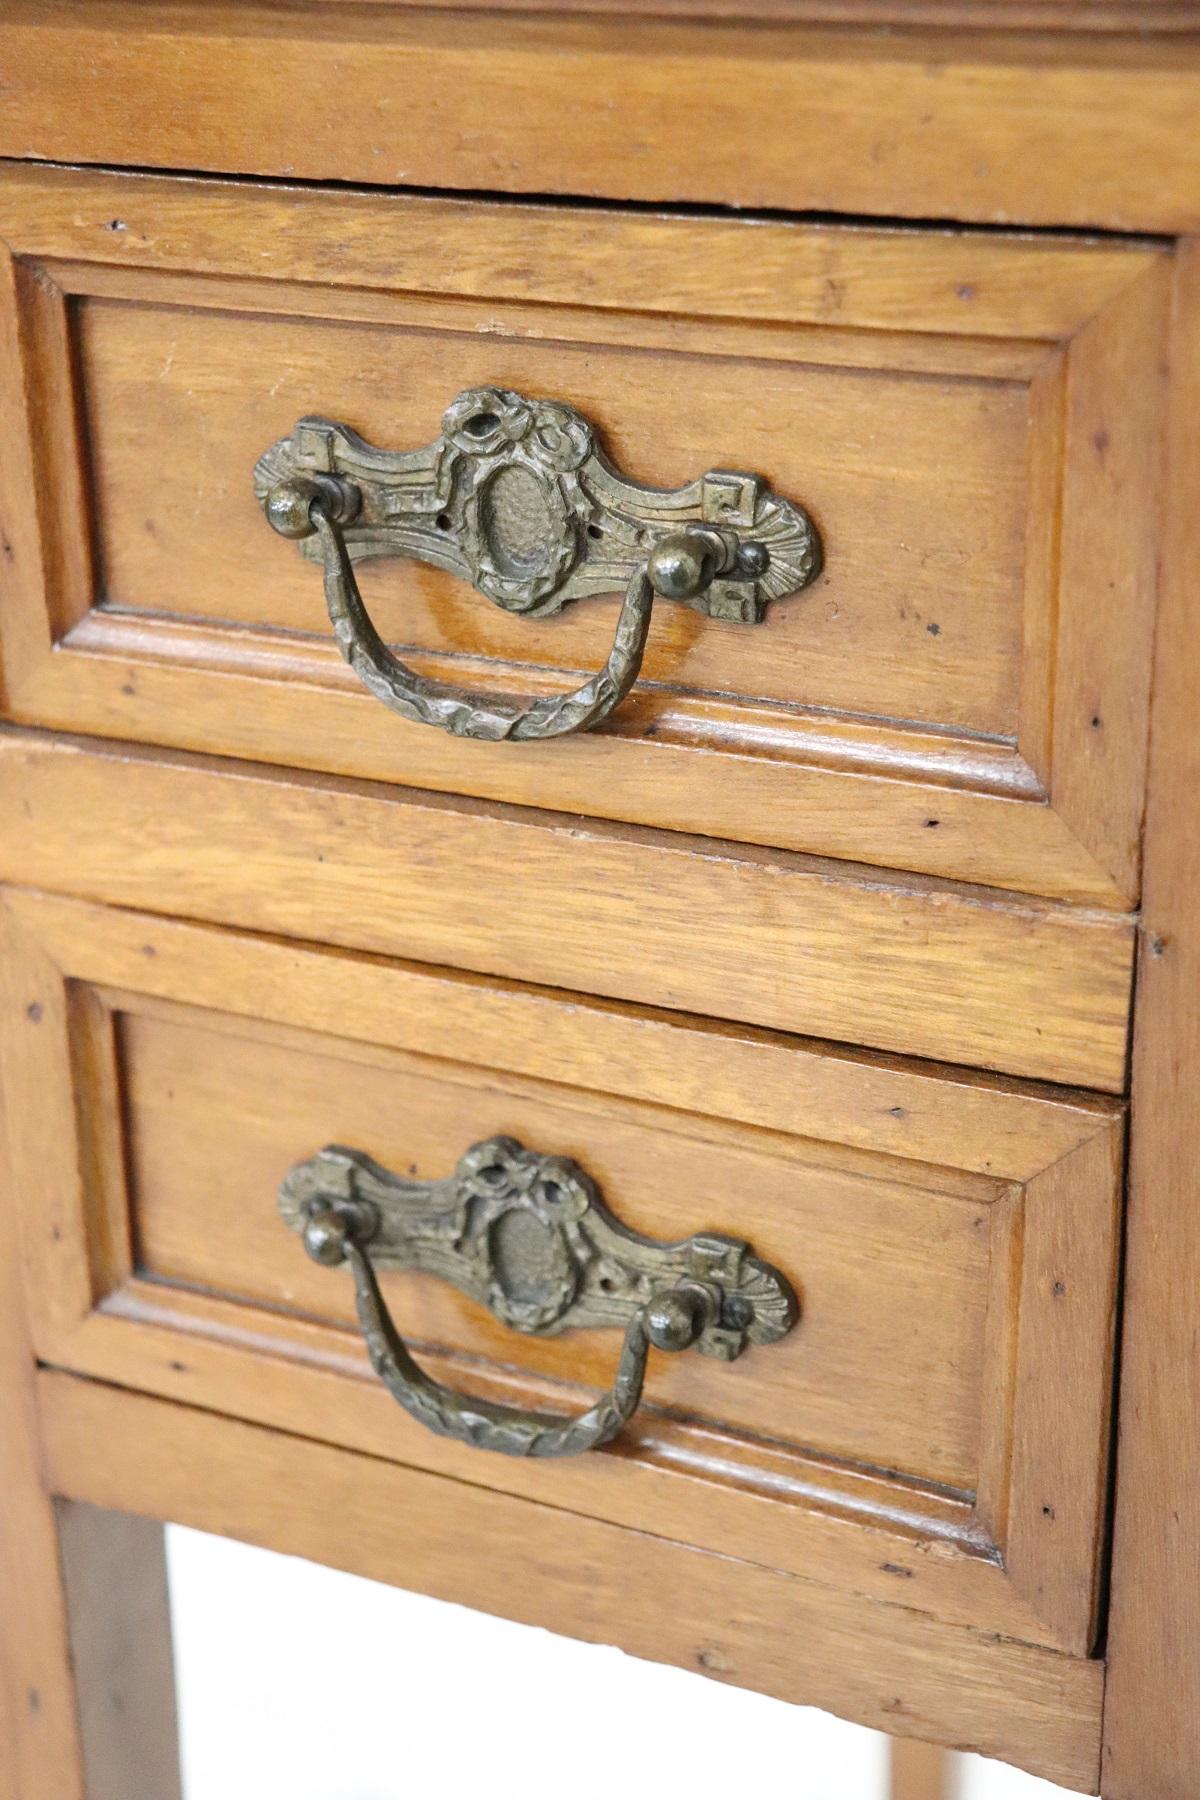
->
(56, 1501), (184, 1800)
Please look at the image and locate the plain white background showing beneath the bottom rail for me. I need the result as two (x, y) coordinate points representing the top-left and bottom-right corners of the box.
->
(167, 1516), (1070, 1800)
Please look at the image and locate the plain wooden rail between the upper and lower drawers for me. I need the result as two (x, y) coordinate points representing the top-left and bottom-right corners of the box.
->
(0, 731), (1132, 1091)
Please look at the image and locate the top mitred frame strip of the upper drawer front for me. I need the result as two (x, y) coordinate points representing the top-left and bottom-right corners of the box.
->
(0, 162), (1162, 342)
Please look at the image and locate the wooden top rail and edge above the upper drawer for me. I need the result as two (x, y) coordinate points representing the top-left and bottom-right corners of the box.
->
(0, 0), (1200, 230)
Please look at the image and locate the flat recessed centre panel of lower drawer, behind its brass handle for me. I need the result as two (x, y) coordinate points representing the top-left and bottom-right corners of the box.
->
(117, 1003), (1004, 1489)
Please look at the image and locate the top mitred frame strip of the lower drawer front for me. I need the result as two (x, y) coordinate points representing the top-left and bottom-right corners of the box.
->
(4, 887), (1114, 1183)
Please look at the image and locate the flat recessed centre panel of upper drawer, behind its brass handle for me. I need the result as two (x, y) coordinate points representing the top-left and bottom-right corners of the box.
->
(77, 301), (1027, 734)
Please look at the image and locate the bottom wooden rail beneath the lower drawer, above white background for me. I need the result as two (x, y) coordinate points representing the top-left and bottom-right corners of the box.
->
(40, 1375), (1101, 1789)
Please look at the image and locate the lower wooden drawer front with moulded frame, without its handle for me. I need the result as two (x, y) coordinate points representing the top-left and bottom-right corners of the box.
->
(5, 891), (1121, 1652)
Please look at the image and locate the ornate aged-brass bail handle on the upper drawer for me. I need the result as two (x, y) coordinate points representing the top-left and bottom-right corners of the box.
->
(254, 387), (820, 740)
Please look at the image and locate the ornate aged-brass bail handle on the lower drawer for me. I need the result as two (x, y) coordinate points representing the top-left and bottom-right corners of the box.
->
(279, 1138), (799, 1456)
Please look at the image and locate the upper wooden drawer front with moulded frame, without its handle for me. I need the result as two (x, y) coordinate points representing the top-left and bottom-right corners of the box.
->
(0, 166), (1169, 905)
